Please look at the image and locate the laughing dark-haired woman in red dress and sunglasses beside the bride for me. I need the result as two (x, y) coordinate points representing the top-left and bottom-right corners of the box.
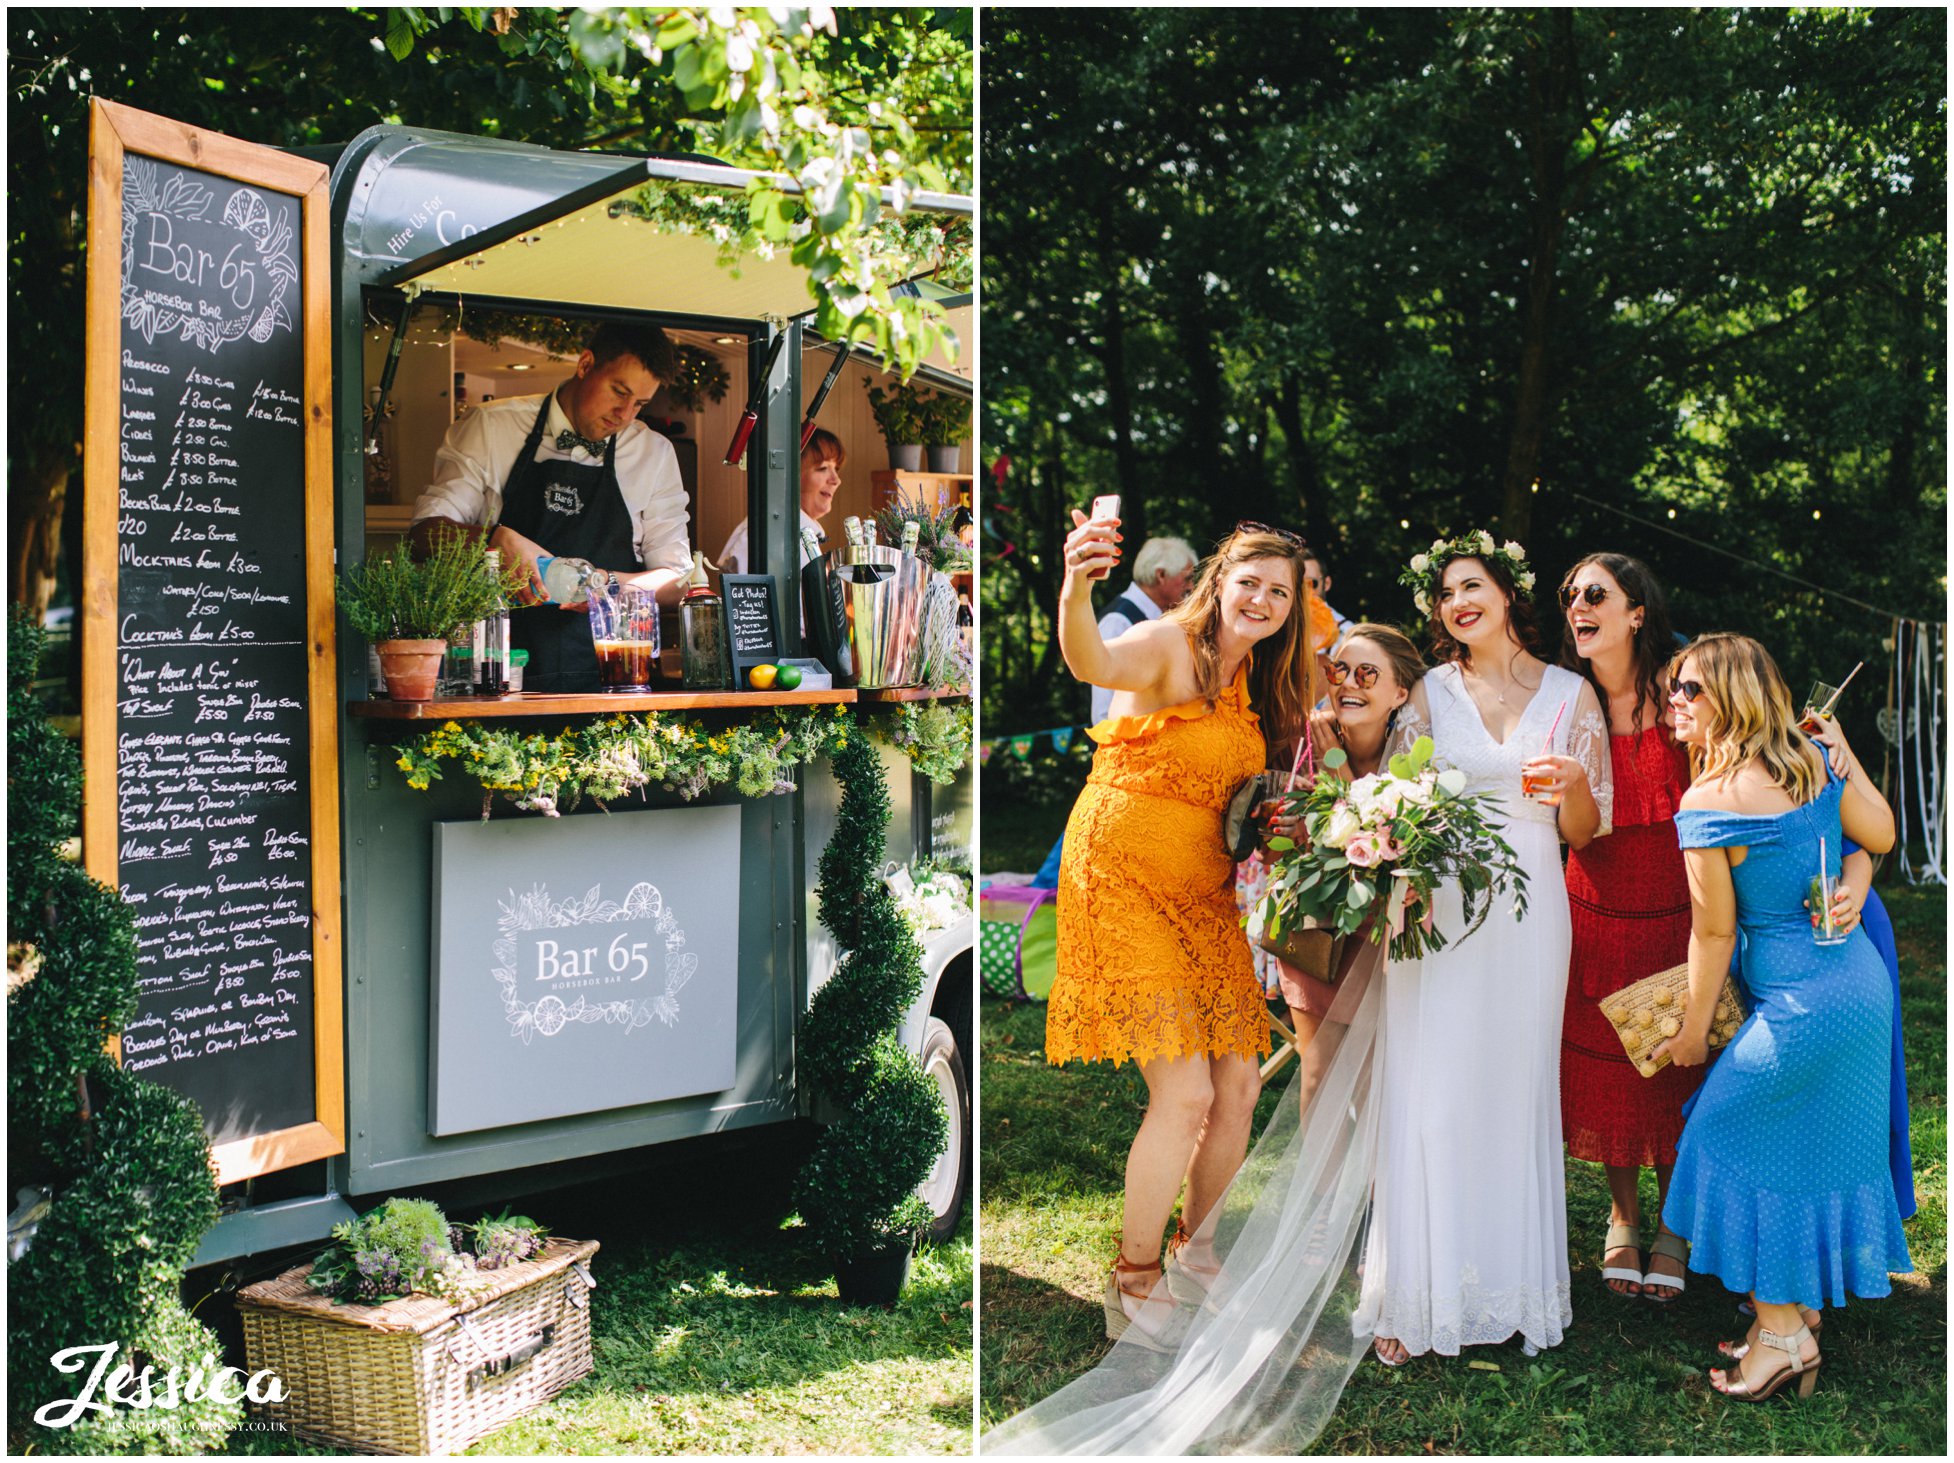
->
(1561, 553), (1702, 1303)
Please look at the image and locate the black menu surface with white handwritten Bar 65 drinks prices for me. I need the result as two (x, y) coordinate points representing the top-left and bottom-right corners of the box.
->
(115, 164), (315, 1143)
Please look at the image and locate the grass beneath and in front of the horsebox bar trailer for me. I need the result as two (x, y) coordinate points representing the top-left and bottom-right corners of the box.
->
(231, 1143), (971, 1455)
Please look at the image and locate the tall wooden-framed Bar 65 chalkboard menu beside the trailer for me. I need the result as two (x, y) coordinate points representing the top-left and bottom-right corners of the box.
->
(80, 100), (346, 1184)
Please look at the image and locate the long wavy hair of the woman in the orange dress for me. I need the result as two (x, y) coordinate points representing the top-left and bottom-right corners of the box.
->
(1163, 529), (1323, 746)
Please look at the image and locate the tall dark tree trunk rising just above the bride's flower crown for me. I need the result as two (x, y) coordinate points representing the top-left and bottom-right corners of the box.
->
(1499, 10), (1575, 543)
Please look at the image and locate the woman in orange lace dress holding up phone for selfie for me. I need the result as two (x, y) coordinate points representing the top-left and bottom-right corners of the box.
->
(1045, 512), (1319, 1346)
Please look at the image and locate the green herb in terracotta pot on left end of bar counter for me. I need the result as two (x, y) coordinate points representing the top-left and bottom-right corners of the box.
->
(338, 533), (516, 701)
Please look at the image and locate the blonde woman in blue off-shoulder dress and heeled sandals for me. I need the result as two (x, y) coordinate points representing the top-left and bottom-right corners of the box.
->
(1657, 635), (1913, 1400)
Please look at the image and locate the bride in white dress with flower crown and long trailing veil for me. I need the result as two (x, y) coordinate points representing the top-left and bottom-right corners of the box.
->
(983, 531), (1612, 1455)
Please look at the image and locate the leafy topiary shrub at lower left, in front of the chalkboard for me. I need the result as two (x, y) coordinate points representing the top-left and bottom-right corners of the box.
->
(8, 613), (242, 1453)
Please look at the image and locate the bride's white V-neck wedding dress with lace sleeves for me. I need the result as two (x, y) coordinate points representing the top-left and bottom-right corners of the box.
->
(1352, 664), (1614, 1356)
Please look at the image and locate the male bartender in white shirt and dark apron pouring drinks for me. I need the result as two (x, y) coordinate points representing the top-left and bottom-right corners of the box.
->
(408, 322), (690, 691)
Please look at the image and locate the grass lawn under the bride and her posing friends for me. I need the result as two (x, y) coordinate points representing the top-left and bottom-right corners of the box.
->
(979, 878), (1948, 1457)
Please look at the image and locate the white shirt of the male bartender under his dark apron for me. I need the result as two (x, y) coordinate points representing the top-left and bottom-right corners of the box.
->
(414, 393), (692, 572)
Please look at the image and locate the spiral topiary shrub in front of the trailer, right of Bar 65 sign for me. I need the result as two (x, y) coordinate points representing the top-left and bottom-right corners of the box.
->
(797, 732), (950, 1260)
